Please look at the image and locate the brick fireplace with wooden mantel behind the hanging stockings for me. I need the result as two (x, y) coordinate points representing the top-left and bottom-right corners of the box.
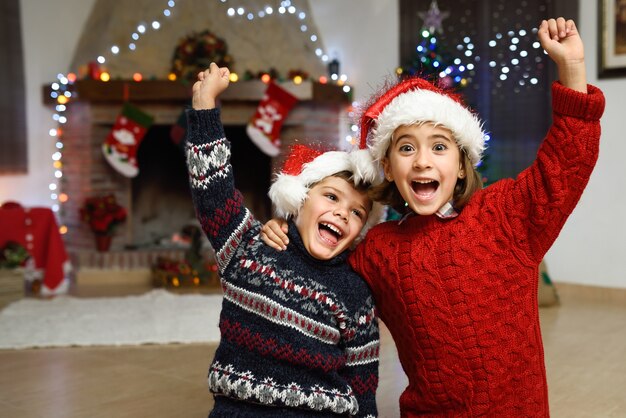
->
(55, 81), (351, 253)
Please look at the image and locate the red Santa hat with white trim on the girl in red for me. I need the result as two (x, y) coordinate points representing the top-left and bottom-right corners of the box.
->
(361, 77), (485, 166)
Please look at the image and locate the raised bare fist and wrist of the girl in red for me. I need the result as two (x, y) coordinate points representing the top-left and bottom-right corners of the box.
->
(537, 17), (587, 93)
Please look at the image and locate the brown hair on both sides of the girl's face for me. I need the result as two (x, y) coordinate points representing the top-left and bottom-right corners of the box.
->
(368, 145), (483, 215)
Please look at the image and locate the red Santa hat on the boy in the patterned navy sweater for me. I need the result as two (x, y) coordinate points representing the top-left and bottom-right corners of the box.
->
(268, 144), (382, 232)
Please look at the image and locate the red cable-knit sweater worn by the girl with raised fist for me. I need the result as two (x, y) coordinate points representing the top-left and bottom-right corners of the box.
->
(349, 83), (604, 417)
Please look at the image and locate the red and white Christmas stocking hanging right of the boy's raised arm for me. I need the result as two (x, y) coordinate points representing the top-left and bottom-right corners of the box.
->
(246, 82), (298, 157)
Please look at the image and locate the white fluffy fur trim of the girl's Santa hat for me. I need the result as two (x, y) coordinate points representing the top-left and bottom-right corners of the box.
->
(369, 89), (485, 166)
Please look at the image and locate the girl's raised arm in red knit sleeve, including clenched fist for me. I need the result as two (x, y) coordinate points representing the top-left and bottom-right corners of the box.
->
(500, 18), (604, 262)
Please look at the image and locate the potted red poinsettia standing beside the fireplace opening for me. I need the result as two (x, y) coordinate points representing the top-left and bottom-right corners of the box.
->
(80, 195), (127, 251)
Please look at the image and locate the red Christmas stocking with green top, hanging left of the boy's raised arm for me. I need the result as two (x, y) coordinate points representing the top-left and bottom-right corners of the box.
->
(102, 103), (153, 177)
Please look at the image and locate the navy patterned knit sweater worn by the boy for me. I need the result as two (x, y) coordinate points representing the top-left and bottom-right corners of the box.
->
(186, 109), (379, 418)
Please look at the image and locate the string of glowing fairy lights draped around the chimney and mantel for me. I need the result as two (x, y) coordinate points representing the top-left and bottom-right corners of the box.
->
(48, 0), (354, 234)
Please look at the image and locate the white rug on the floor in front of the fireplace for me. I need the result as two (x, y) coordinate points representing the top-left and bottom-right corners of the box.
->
(0, 289), (222, 348)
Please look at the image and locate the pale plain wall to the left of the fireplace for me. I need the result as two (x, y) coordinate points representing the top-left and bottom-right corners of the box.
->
(0, 0), (94, 206)
